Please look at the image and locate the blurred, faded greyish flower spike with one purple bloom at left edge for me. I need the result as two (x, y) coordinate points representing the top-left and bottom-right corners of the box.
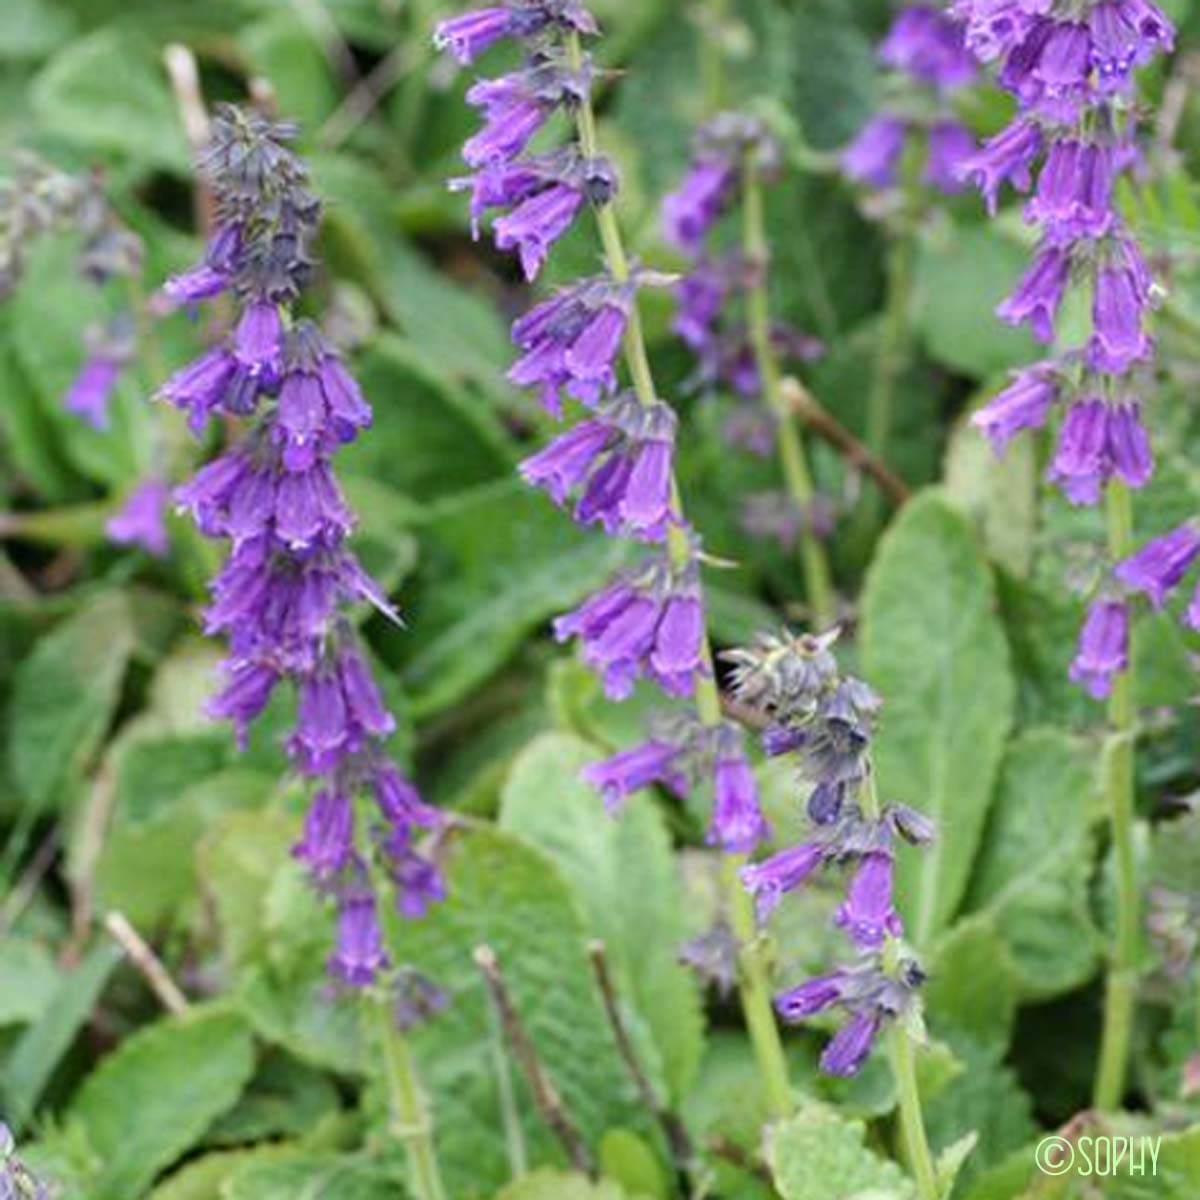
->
(0, 155), (142, 430)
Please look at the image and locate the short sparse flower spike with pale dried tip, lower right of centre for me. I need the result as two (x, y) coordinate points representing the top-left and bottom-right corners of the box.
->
(726, 632), (934, 1075)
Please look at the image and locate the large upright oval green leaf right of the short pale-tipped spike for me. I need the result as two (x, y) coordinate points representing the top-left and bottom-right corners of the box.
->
(862, 492), (1015, 947)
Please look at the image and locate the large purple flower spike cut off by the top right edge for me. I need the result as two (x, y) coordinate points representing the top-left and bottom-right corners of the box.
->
(955, 0), (1174, 697)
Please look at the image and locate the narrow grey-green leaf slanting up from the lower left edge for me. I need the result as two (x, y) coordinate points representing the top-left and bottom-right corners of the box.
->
(0, 941), (121, 1126)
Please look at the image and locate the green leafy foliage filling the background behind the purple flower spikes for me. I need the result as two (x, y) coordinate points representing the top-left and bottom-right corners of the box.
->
(0, 0), (1200, 1200)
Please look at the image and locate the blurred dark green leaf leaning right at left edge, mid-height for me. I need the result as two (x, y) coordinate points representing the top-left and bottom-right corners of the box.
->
(8, 592), (134, 809)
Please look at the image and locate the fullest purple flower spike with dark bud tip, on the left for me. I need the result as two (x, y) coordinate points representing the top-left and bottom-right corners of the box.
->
(161, 108), (443, 985)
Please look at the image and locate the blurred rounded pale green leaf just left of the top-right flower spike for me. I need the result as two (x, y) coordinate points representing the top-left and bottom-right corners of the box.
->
(916, 222), (1038, 379)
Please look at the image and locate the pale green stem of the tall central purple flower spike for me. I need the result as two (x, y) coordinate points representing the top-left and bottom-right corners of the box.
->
(566, 35), (792, 1116)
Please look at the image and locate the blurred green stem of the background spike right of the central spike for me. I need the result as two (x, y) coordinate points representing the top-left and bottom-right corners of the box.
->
(742, 157), (838, 630)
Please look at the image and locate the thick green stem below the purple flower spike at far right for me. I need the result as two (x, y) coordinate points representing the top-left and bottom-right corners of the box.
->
(1092, 480), (1140, 1110)
